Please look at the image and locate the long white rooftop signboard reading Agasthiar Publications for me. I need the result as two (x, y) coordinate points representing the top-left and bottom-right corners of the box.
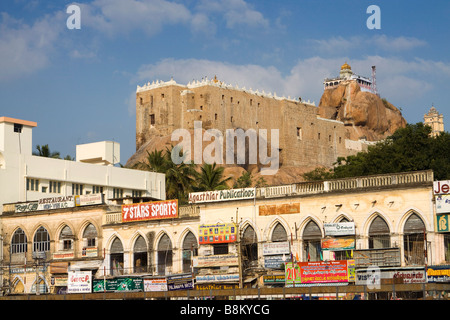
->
(189, 188), (256, 203)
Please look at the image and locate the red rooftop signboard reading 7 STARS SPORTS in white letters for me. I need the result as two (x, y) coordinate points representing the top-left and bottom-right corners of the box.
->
(122, 200), (178, 222)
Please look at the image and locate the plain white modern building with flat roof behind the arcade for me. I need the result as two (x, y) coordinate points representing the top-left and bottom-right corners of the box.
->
(0, 117), (165, 214)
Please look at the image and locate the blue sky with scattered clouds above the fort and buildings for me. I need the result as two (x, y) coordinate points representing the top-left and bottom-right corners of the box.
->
(0, 0), (450, 164)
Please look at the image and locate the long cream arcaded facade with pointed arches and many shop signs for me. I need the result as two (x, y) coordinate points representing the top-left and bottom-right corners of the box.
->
(2, 171), (450, 293)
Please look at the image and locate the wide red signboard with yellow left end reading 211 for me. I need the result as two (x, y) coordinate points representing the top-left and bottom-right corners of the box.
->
(285, 260), (354, 286)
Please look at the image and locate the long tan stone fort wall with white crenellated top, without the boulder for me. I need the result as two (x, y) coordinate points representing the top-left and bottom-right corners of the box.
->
(136, 80), (366, 167)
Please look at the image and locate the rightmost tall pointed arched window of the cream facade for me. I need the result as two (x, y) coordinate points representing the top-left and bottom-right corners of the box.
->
(403, 213), (425, 265)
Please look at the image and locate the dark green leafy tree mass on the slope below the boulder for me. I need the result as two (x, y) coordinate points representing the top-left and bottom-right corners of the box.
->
(303, 122), (450, 180)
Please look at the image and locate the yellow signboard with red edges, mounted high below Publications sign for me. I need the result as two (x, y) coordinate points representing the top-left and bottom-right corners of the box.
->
(198, 223), (237, 244)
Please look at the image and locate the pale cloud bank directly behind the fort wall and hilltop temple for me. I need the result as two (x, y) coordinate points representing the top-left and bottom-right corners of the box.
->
(133, 56), (450, 109)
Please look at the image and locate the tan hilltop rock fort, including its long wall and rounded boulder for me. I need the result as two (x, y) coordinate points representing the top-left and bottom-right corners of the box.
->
(127, 64), (406, 183)
